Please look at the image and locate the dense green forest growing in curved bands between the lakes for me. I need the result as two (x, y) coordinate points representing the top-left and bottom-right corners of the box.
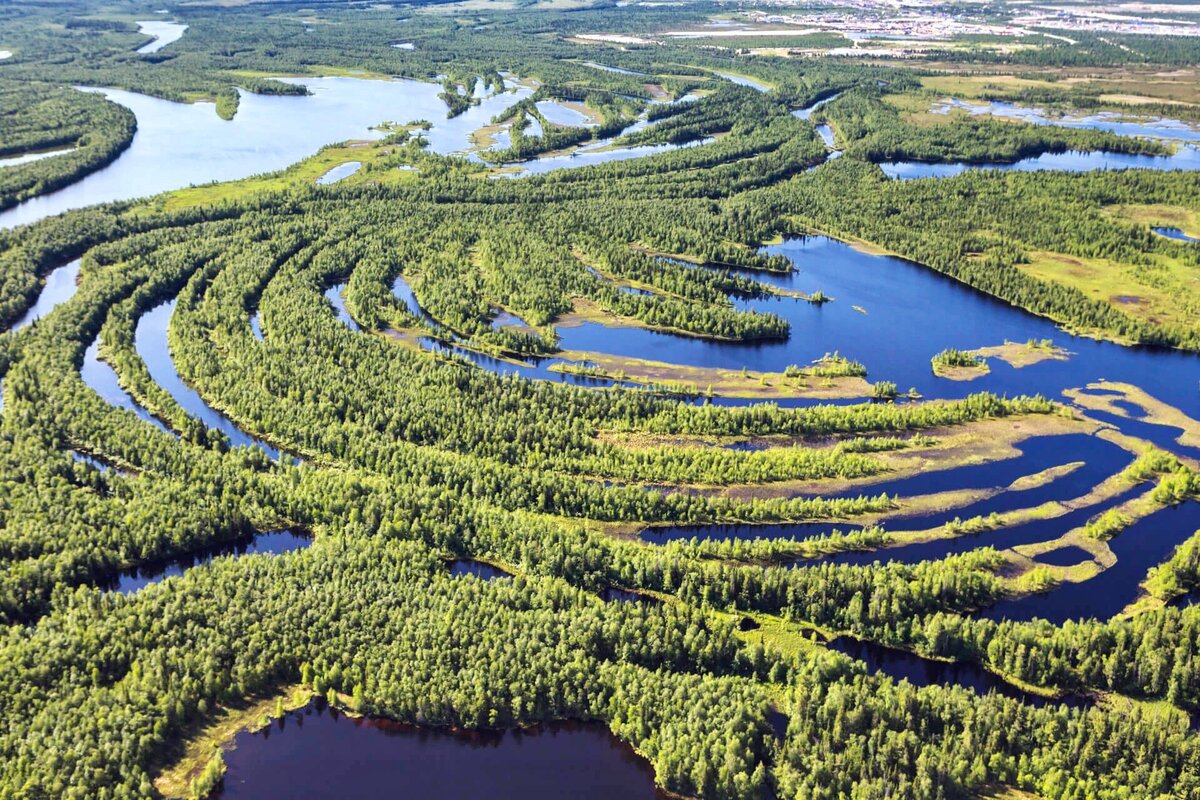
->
(0, 0), (1200, 800)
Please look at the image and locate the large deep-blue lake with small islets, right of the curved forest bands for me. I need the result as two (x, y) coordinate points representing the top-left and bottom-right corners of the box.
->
(396, 227), (1200, 465)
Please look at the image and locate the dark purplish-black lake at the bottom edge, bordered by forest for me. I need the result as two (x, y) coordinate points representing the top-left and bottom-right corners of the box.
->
(215, 702), (665, 800)
